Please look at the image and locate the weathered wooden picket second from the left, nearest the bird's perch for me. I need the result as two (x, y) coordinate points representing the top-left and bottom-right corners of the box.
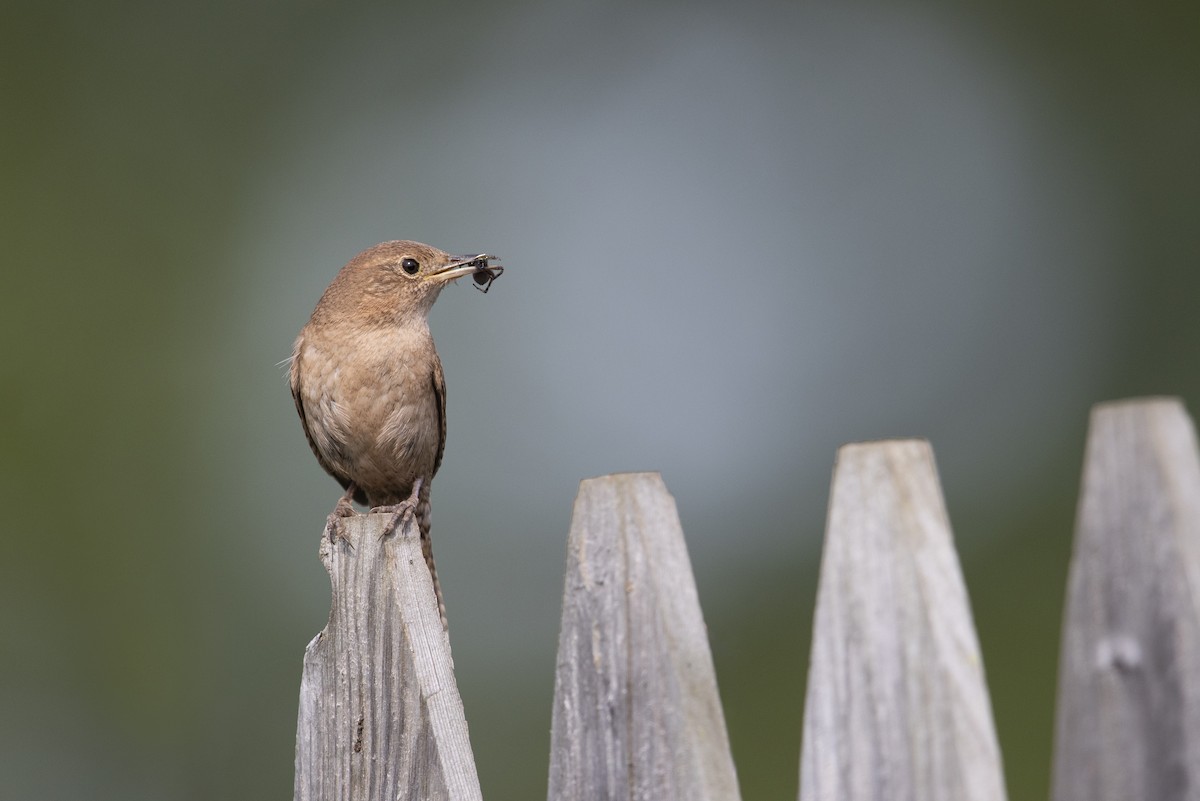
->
(548, 472), (739, 801)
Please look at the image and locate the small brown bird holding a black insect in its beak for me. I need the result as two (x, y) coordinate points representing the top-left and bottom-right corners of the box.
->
(290, 241), (503, 625)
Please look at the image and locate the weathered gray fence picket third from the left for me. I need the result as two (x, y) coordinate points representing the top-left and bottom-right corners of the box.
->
(799, 440), (1006, 801)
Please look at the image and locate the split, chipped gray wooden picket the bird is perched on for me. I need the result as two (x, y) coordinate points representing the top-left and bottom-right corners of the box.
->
(295, 514), (481, 801)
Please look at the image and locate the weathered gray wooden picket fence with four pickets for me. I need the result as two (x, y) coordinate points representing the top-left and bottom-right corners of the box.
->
(295, 398), (1200, 801)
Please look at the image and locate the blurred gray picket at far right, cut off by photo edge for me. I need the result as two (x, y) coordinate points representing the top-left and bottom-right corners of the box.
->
(1046, 398), (1200, 801)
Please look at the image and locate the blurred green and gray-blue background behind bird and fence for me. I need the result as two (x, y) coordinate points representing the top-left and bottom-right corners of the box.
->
(0, 0), (1200, 801)
